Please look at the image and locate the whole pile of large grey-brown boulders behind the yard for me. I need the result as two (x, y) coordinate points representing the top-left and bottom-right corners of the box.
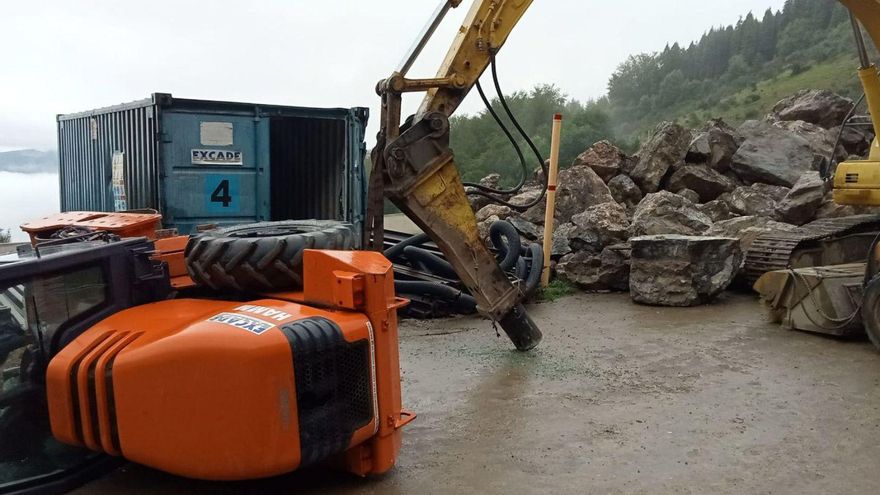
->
(473, 90), (873, 305)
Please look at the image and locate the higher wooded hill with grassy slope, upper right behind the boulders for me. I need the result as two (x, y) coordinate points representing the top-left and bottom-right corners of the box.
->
(607, 0), (877, 136)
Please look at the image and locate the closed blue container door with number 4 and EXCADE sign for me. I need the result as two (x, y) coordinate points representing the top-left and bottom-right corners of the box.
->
(162, 111), (268, 234)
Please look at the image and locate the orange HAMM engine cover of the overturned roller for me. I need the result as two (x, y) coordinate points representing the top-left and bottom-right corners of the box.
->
(46, 251), (413, 480)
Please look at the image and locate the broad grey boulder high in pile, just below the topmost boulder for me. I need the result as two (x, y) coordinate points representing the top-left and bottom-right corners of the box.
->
(731, 121), (814, 187)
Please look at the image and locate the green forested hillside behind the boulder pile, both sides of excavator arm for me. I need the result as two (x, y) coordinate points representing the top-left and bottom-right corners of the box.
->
(452, 0), (876, 182)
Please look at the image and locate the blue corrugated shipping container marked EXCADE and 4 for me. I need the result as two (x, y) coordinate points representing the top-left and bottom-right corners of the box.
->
(57, 93), (369, 238)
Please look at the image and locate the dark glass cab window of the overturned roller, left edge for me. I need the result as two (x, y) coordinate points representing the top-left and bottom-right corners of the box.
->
(0, 267), (107, 492)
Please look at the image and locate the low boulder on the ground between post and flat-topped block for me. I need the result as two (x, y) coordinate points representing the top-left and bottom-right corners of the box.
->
(556, 245), (629, 291)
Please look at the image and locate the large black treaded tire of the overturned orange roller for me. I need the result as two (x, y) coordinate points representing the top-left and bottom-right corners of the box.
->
(185, 220), (354, 291)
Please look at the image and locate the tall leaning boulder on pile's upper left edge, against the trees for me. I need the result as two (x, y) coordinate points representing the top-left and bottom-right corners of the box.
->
(630, 122), (691, 193)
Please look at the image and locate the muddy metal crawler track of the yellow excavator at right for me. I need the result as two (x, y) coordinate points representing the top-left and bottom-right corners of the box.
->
(745, 215), (880, 284)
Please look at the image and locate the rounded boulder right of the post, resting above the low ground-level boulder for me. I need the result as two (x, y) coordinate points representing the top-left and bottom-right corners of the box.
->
(568, 202), (630, 253)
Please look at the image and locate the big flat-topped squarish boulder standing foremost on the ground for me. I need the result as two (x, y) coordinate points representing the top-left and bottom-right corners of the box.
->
(629, 235), (743, 306)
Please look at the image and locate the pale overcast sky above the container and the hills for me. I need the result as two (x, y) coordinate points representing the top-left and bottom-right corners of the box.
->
(0, 0), (783, 150)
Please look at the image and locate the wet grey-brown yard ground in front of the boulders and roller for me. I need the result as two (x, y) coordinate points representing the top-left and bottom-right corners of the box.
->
(79, 294), (880, 494)
